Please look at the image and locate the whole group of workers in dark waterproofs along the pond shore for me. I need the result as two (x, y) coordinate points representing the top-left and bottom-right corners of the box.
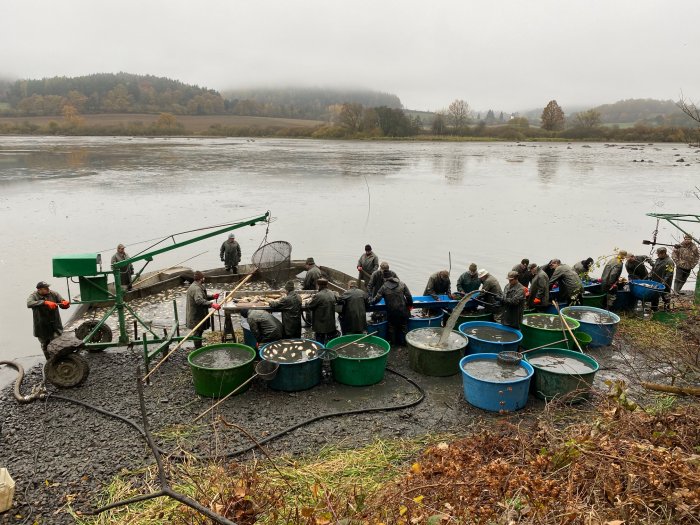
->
(27, 234), (700, 359)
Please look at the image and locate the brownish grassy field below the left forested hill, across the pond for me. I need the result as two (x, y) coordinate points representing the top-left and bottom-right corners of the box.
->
(0, 113), (323, 133)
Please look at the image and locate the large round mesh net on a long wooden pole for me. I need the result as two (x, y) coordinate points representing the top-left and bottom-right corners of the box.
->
(143, 241), (292, 381)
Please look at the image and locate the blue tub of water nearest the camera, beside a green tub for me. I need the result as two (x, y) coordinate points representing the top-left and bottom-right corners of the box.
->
(459, 354), (534, 412)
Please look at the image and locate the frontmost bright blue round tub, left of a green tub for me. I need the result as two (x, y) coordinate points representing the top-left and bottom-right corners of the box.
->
(459, 354), (534, 412)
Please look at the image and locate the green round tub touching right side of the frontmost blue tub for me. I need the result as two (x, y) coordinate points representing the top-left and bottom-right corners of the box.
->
(524, 348), (599, 403)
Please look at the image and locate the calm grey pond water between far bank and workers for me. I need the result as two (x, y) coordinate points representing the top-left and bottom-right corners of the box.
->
(0, 137), (700, 373)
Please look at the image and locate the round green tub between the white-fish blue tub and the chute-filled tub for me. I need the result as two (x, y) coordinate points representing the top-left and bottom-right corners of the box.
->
(326, 334), (391, 386)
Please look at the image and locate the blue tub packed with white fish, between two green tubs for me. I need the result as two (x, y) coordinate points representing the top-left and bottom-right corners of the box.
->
(260, 339), (325, 392)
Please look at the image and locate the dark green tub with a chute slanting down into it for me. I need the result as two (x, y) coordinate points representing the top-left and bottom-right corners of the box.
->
(406, 327), (469, 377)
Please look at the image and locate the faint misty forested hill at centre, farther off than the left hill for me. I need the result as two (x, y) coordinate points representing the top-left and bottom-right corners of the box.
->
(222, 87), (402, 120)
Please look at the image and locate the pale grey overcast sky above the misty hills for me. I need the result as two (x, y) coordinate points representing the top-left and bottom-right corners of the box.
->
(5, 0), (700, 111)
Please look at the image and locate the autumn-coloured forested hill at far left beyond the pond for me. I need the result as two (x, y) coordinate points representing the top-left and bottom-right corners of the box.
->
(0, 73), (226, 115)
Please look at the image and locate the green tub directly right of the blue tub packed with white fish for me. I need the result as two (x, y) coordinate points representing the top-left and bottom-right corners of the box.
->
(326, 334), (391, 386)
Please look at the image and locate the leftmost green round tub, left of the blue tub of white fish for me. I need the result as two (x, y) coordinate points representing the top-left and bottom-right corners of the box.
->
(187, 343), (255, 397)
